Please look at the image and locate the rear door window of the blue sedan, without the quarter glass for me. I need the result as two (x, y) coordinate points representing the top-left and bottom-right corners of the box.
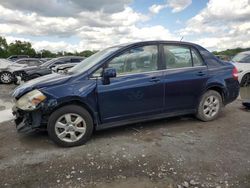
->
(163, 45), (192, 69)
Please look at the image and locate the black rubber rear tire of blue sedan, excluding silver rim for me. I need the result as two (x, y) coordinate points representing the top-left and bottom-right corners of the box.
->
(196, 90), (223, 121)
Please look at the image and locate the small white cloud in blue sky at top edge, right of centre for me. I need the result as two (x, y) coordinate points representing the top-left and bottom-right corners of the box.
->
(149, 0), (192, 14)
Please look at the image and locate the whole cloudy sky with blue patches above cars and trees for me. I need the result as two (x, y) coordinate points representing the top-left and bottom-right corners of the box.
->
(0, 0), (250, 52)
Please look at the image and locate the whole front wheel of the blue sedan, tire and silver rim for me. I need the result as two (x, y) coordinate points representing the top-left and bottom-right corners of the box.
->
(47, 105), (94, 147)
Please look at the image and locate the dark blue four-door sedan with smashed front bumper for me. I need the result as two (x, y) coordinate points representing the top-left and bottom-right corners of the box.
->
(13, 41), (239, 146)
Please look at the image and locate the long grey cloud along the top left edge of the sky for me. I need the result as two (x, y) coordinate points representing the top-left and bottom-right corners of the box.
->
(0, 0), (132, 17)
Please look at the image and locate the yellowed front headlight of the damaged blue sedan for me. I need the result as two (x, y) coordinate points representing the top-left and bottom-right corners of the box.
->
(16, 89), (46, 110)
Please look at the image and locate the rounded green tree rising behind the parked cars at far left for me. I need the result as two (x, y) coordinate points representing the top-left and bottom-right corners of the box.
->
(8, 40), (36, 57)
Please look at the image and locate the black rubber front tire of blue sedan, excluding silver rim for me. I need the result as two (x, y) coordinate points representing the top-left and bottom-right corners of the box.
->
(47, 105), (93, 147)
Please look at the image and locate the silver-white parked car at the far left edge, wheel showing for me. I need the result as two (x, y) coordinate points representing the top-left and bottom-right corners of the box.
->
(0, 58), (42, 84)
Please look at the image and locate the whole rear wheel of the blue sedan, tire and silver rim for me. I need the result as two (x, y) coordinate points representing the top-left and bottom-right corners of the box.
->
(196, 90), (223, 121)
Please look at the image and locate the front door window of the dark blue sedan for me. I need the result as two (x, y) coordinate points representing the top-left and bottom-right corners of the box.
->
(108, 45), (158, 75)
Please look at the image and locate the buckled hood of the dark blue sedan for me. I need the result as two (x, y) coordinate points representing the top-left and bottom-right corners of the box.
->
(12, 73), (72, 98)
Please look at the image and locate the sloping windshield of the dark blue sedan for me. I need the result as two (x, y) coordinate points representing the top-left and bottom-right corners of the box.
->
(68, 47), (119, 74)
